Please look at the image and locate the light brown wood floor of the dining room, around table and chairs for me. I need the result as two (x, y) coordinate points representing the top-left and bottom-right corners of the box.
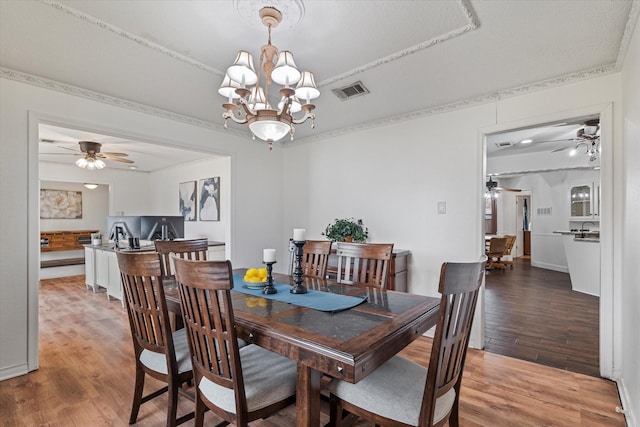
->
(0, 276), (625, 427)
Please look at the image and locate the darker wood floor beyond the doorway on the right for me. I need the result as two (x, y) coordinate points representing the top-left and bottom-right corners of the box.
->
(485, 258), (600, 377)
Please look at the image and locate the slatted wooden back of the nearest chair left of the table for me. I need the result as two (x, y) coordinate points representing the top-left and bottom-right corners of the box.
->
(173, 258), (246, 402)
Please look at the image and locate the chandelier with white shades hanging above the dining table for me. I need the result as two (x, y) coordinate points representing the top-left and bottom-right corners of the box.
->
(218, 7), (320, 150)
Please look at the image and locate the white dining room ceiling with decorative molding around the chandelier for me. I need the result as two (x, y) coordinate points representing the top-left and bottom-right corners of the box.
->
(0, 0), (640, 171)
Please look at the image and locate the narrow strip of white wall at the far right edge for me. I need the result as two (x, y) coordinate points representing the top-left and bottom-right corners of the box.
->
(618, 11), (640, 427)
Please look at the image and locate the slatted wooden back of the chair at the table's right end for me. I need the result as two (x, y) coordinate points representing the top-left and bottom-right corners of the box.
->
(419, 261), (485, 425)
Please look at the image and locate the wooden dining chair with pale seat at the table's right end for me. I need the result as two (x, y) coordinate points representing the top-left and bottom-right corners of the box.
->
(327, 261), (485, 427)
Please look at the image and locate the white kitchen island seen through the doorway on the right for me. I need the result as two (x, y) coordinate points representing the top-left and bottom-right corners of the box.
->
(554, 230), (600, 297)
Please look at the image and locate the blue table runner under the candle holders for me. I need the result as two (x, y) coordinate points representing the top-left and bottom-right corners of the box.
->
(233, 274), (367, 312)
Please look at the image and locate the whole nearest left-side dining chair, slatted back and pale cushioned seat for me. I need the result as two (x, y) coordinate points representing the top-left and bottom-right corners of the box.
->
(174, 258), (296, 426)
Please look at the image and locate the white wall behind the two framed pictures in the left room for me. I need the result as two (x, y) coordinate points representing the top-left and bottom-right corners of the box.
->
(147, 157), (231, 242)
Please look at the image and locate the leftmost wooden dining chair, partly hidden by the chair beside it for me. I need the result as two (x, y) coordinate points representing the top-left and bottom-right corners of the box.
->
(117, 252), (194, 426)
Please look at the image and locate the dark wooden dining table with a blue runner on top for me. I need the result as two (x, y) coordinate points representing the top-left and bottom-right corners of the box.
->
(165, 269), (440, 427)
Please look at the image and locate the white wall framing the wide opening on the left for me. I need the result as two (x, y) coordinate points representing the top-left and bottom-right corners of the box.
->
(0, 78), (286, 379)
